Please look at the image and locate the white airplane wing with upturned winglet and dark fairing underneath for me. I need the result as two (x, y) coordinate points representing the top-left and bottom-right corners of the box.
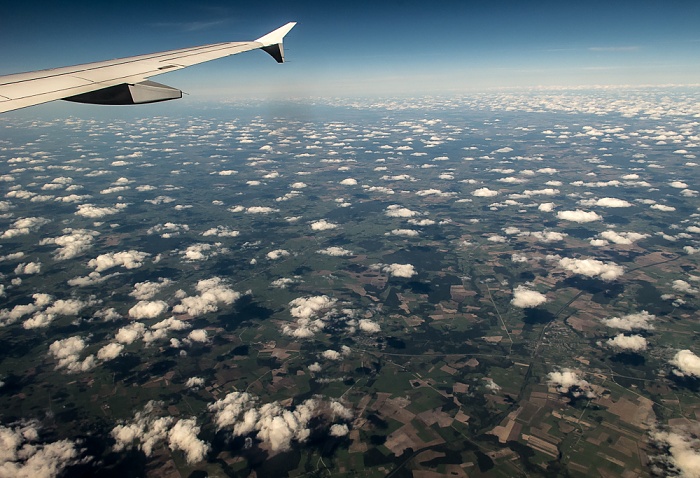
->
(0, 22), (296, 113)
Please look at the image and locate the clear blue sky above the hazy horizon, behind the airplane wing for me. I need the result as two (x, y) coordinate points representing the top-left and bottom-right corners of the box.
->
(0, 0), (700, 96)
